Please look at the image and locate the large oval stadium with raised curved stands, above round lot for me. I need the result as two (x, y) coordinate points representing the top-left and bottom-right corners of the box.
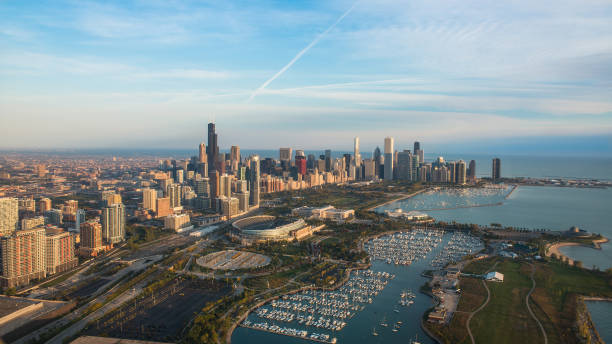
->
(230, 215), (314, 244)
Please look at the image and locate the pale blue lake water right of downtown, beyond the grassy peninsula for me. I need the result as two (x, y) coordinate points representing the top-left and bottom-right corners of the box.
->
(376, 186), (612, 269)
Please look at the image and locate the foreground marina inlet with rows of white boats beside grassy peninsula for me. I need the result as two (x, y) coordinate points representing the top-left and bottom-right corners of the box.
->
(235, 228), (482, 343)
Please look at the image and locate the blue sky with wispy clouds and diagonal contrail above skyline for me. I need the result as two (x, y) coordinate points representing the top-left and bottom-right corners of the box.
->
(0, 0), (612, 155)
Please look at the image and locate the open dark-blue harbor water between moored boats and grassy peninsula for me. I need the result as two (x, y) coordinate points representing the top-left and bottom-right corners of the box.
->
(232, 233), (470, 344)
